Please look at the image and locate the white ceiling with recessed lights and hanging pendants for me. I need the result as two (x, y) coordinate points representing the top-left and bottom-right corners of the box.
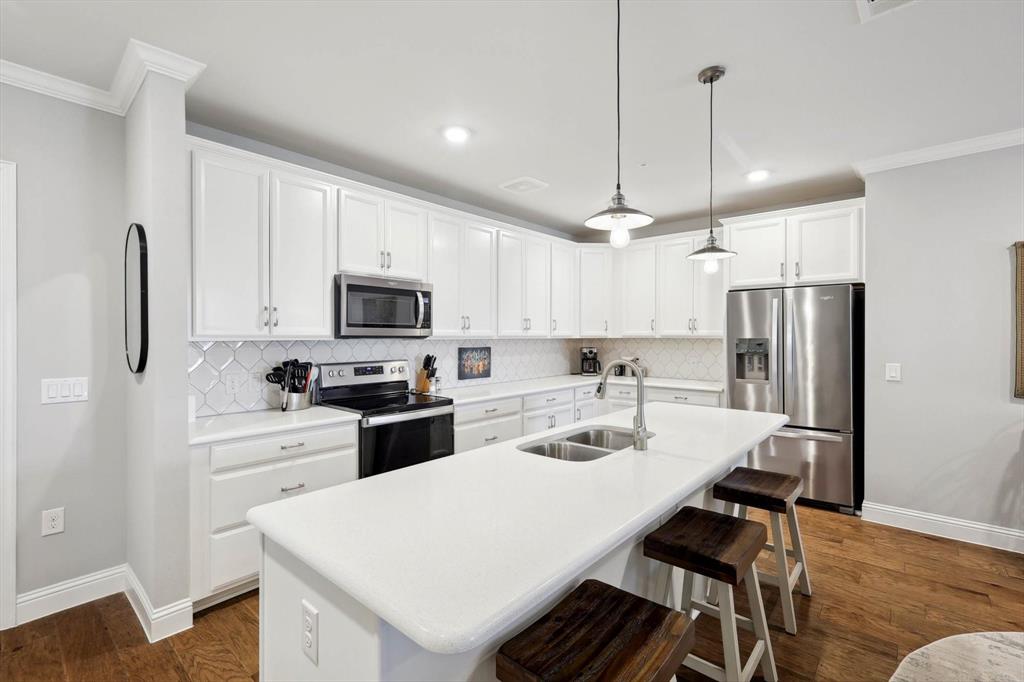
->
(0, 0), (1024, 233)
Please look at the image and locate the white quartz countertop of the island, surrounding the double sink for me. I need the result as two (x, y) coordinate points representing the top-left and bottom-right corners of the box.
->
(246, 402), (787, 653)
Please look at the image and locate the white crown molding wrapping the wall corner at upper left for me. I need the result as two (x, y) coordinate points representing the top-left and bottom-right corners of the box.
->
(0, 38), (206, 116)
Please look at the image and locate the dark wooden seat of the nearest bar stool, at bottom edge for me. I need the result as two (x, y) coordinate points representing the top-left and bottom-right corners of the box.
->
(496, 580), (694, 682)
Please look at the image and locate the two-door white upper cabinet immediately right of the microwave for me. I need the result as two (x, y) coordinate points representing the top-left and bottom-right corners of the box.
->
(430, 213), (498, 337)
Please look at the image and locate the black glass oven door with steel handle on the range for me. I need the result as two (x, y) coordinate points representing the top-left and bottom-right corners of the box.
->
(359, 406), (455, 478)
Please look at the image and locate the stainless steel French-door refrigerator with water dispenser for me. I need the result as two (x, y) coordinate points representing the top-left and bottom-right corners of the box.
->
(726, 285), (864, 513)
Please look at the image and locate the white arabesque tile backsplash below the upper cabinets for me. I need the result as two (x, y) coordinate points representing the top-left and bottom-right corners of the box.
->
(188, 339), (725, 417)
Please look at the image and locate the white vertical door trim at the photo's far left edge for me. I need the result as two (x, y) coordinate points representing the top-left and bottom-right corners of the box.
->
(0, 161), (17, 630)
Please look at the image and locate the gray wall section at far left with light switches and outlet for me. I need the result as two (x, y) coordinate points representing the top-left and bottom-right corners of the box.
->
(0, 85), (126, 593)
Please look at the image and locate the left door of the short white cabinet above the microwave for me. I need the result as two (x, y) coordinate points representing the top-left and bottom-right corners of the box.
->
(338, 188), (386, 274)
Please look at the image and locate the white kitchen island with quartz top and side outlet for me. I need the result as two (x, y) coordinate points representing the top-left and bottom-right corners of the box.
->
(247, 403), (786, 680)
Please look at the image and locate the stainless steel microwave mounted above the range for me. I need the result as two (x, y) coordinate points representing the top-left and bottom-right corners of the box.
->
(334, 272), (433, 339)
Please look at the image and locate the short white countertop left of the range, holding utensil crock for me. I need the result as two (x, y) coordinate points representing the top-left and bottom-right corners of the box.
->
(188, 406), (359, 445)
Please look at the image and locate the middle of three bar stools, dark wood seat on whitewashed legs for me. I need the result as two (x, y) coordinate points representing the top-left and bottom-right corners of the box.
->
(643, 507), (778, 682)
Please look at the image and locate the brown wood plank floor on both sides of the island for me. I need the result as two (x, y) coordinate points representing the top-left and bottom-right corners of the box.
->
(0, 507), (1024, 682)
